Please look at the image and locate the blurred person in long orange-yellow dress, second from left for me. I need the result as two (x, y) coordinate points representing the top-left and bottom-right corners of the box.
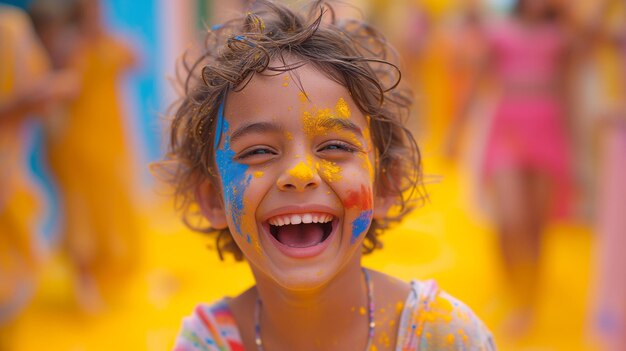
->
(30, 0), (139, 312)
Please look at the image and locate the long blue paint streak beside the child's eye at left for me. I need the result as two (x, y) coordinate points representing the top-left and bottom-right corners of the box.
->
(214, 103), (252, 235)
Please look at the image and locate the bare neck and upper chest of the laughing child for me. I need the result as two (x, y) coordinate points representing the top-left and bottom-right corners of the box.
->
(255, 257), (368, 350)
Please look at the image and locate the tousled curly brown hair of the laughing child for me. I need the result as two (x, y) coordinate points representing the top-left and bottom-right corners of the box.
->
(157, 0), (423, 260)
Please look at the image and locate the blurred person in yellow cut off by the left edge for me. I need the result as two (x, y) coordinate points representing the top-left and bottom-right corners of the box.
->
(0, 4), (78, 349)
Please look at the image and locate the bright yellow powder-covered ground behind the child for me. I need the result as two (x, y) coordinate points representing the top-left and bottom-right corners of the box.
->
(3, 141), (592, 351)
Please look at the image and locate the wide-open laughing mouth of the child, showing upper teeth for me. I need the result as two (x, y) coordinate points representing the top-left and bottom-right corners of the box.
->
(267, 213), (334, 248)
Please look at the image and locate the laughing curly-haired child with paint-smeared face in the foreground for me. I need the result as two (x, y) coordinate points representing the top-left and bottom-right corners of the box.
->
(161, 1), (495, 351)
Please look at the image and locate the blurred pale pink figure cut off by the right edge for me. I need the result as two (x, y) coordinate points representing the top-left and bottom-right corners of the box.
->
(592, 0), (626, 351)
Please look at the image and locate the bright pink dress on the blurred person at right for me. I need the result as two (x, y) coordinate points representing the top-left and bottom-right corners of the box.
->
(484, 21), (570, 216)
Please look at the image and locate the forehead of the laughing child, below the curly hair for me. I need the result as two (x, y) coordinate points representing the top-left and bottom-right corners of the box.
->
(225, 62), (364, 125)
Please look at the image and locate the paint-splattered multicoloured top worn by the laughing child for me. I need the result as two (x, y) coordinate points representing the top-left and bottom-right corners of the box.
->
(174, 280), (496, 351)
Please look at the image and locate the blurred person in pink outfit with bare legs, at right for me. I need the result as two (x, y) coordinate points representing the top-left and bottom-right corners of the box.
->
(446, 0), (574, 336)
